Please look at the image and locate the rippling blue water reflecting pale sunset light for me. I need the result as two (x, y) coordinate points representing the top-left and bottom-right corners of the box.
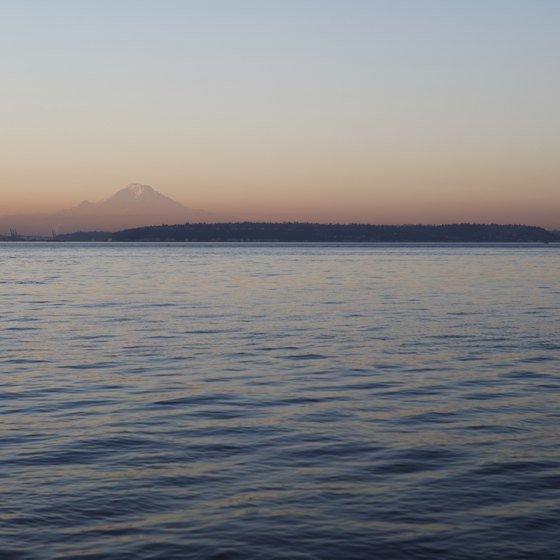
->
(0, 243), (560, 560)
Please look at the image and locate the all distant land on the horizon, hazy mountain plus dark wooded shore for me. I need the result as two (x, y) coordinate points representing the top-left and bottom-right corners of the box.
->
(0, 183), (560, 243)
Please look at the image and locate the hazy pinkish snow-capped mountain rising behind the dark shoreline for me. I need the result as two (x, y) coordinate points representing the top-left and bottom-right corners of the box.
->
(0, 183), (225, 235)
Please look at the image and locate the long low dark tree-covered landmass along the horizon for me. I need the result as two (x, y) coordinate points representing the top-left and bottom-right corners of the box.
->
(103, 222), (560, 243)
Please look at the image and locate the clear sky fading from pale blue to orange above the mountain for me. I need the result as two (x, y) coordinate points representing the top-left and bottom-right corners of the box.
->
(0, 0), (560, 227)
